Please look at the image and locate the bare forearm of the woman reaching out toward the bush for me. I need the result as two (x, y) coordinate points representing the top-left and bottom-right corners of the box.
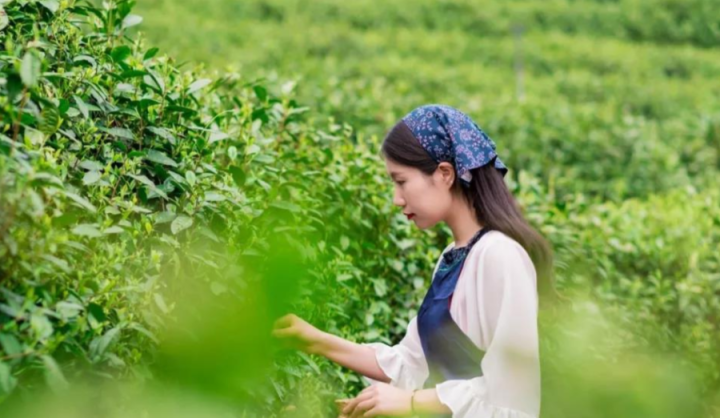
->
(316, 333), (390, 383)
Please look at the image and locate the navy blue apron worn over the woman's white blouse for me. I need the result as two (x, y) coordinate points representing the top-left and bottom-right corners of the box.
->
(417, 227), (489, 418)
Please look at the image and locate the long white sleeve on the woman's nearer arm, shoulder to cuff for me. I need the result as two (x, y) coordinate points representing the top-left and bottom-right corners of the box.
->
(436, 237), (540, 418)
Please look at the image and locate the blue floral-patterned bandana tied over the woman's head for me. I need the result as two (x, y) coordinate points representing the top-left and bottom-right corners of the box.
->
(403, 104), (508, 187)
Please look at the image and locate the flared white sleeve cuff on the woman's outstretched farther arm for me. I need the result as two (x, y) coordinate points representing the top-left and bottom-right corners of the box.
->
(362, 316), (429, 390)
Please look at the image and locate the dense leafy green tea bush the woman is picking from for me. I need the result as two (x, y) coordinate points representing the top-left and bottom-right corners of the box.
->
(0, 1), (462, 414)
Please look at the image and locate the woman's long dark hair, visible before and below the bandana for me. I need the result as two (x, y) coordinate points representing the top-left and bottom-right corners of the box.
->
(381, 120), (558, 301)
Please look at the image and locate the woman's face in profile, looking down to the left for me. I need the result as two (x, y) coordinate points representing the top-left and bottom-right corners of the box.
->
(385, 158), (455, 229)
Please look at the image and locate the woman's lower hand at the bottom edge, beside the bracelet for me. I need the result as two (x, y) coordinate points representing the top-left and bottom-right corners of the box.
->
(343, 382), (412, 418)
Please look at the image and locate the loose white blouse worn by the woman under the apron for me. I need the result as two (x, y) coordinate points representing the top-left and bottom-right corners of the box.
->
(362, 230), (540, 418)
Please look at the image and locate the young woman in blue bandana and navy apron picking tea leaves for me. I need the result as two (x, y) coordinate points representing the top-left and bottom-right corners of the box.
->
(273, 105), (552, 418)
